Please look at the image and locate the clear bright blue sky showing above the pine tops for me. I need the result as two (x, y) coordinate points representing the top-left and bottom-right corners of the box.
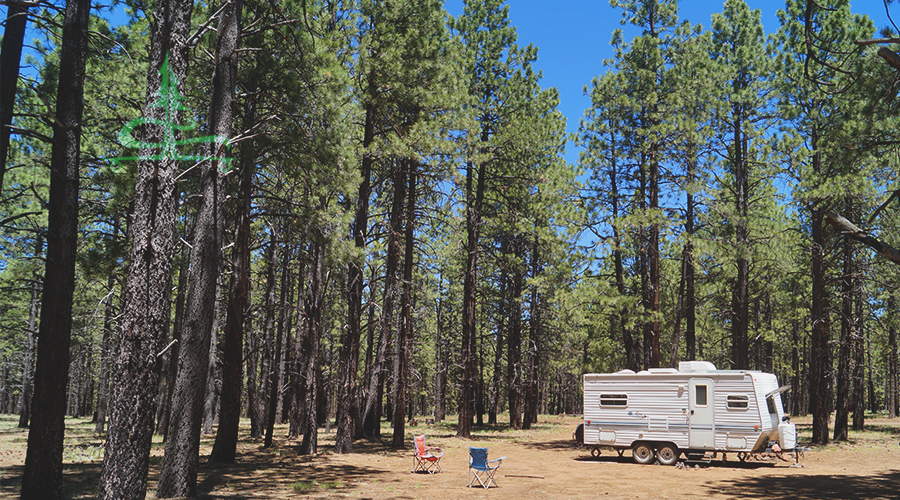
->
(444, 0), (900, 167)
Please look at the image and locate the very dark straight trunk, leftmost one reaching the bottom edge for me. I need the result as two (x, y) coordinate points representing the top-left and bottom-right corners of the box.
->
(17, 0), (90, 500)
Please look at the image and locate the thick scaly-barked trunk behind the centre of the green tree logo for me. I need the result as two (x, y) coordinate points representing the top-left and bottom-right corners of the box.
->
(99, 0), (193, 494)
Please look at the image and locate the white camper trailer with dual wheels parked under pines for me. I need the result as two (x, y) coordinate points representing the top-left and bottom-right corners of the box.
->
(583, 361), (796, 465)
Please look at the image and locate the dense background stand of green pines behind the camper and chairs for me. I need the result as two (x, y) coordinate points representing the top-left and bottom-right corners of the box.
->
(0, 0), (900, 499)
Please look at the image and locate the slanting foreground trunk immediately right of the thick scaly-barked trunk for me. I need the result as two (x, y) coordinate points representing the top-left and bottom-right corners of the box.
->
(157, 0), (243, 498)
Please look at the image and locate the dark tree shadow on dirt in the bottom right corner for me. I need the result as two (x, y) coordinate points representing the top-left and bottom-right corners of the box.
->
(704, 470), (900, 500)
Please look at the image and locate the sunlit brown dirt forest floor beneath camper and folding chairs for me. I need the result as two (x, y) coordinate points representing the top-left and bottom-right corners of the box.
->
(0, 415), (900, 500)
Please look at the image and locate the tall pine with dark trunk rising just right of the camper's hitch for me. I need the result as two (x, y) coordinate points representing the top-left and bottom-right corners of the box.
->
(776, 1), (872, 444)
